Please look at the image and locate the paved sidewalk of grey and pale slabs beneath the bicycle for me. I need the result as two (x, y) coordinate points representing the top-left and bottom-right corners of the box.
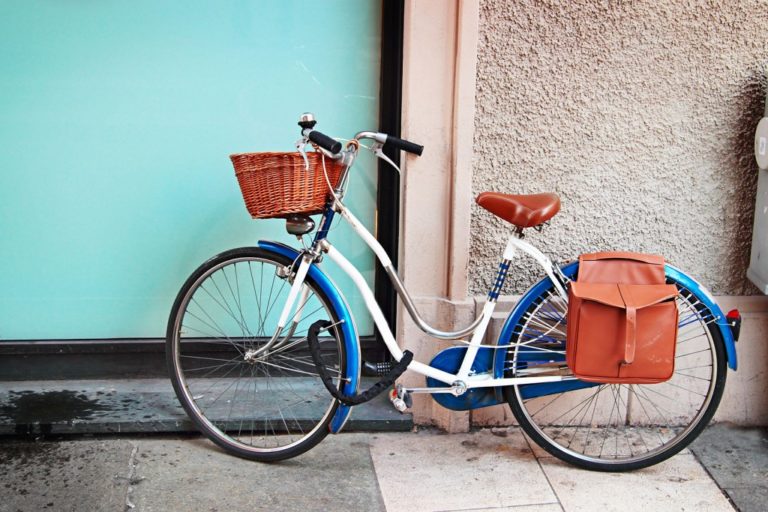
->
(0, 428), (766, 512)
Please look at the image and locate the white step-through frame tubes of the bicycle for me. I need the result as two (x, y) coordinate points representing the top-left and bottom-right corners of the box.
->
(277, 200), (573, 394)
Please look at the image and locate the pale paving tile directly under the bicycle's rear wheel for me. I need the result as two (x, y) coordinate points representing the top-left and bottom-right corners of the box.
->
(540, 454), (733, 512)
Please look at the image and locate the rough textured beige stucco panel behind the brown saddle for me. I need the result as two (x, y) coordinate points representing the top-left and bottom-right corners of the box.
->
(469, 0), (768, 294)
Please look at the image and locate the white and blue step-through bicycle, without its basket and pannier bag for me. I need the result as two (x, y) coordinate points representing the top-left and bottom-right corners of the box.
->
(167, 114), (740, 471)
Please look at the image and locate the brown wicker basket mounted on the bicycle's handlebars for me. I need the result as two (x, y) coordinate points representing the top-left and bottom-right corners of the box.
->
(229, 151), (344, 219)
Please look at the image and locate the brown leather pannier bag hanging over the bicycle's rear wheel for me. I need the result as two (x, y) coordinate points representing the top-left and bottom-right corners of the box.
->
(565, 252), (677, 384)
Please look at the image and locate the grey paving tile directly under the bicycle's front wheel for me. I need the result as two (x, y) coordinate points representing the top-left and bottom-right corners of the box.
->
(132, 434), (385, 512)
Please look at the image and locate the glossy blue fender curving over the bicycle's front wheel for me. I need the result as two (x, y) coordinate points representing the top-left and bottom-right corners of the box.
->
(256, 240), (361, 434)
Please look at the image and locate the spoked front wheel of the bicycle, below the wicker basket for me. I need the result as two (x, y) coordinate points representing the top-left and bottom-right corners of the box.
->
(166, 248), (349, 461)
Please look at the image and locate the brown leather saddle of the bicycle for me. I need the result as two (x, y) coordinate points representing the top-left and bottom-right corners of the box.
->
(476, 192), (560, 230)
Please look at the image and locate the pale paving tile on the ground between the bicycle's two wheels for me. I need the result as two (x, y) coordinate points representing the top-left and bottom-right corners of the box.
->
(370, 431), (559, 512)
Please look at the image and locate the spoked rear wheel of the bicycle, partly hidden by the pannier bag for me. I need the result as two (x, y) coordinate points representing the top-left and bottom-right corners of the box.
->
(500, 268), (726, 471)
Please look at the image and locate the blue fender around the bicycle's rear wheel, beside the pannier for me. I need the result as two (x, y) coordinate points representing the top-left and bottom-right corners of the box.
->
(493, 261), (738, 398)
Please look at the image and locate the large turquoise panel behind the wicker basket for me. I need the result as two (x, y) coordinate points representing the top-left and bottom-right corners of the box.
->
(0, 0), (381, 340)
